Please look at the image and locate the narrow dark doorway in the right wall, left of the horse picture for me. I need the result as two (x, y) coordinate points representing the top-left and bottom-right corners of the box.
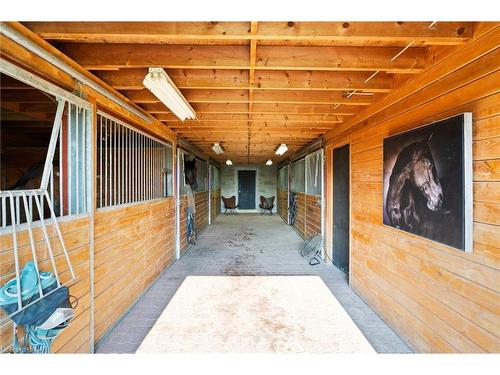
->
(333, 145), (349, 273)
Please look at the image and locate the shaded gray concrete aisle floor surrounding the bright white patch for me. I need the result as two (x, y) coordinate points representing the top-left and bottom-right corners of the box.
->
(96, 214), (411, 353)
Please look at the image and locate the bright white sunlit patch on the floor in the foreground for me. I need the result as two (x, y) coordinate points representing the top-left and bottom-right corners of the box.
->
(137, 276), (375, 353)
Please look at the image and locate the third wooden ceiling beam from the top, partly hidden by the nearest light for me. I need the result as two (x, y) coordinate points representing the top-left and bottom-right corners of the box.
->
(94, 68), (393, 93)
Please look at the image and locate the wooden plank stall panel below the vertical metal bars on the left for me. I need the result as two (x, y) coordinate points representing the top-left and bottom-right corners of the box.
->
(94, 197), (175, 341)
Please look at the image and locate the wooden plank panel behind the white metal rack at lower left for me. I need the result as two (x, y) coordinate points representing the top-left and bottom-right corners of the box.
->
(0, 217), (90, 353)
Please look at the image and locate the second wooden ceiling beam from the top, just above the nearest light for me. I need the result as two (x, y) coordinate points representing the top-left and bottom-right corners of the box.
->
(58, 43), (425, 73)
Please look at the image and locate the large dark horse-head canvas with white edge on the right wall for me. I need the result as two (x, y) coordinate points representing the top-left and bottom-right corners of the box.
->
(383, 113), (472, 252)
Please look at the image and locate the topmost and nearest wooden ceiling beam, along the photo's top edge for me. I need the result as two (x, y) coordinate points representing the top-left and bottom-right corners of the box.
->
(24, 22), (473, 45)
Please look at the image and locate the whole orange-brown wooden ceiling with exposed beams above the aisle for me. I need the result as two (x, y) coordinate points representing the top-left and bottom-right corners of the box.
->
(15, 22), (482, 163)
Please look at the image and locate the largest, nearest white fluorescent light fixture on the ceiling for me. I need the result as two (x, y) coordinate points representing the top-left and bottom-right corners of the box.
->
(142, 68), (196, 121)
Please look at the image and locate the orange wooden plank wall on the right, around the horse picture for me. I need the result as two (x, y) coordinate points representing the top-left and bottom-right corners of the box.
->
(327, 28), (500, 352)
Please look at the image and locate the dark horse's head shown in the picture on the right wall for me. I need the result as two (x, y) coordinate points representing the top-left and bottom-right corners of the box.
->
(386, 134), (443, 230)
